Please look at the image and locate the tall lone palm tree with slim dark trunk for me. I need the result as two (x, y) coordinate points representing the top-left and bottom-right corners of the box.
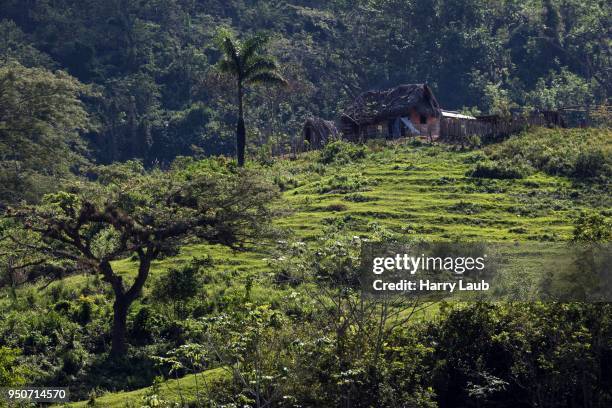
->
(218, 32), (286, 167)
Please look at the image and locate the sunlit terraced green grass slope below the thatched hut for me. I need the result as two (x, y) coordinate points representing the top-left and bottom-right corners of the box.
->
(278, 144), (611, 241)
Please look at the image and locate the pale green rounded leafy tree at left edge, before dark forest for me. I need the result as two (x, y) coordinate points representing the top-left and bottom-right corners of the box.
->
(0, 62), (90, 202)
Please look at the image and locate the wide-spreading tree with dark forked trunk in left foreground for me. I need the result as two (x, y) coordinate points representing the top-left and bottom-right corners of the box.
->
(5, 162), (275, 357)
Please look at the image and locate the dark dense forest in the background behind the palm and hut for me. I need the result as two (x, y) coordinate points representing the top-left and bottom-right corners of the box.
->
(0, 0), (612, 204)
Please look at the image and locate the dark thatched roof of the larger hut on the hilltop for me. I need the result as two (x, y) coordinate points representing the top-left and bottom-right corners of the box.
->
(340, 84), (440, 126)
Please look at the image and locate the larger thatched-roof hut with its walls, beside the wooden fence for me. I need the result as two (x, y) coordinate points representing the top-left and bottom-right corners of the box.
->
(340, 84), (441, 141)
